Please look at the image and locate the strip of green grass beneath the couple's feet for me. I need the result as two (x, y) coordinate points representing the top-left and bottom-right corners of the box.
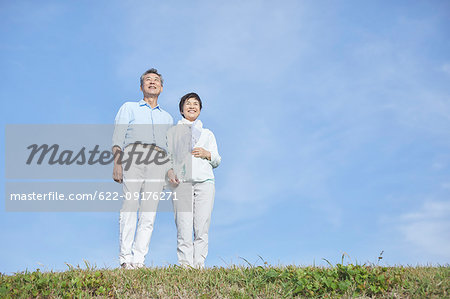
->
(0, 264), (450, 298)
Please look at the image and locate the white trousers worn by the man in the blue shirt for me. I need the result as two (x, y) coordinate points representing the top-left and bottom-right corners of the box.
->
(119, 149), (166, 264)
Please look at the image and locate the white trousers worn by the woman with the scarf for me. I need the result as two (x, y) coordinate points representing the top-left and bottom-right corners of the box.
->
(173, 182), (215, 268)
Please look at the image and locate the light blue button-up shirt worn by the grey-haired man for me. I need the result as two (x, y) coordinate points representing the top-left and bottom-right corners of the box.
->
(112, 100), (173, 151)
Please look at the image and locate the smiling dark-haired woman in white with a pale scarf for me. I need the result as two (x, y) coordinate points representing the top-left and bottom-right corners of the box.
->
(167, 93), (221, 268)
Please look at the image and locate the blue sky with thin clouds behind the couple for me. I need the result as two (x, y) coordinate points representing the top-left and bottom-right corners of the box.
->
(0, 0), (450, 273)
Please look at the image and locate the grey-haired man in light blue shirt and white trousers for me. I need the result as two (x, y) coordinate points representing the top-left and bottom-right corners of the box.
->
(112, 68), (173, 269)
